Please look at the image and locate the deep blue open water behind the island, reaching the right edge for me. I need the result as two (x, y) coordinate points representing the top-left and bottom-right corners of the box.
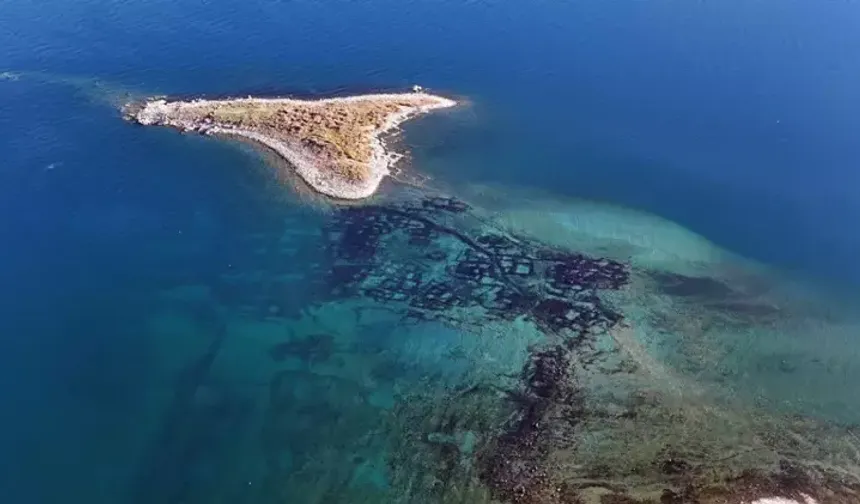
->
(0, 2), (860, 280)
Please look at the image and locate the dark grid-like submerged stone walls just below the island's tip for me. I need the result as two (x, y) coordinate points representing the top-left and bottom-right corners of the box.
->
(316, 197), (629, 340)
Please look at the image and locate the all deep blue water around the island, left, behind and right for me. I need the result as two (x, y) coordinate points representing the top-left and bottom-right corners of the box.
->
(0, 0), (860, 503)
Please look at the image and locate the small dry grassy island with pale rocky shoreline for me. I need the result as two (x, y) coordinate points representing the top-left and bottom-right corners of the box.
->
(125, 86), (457, 199)
